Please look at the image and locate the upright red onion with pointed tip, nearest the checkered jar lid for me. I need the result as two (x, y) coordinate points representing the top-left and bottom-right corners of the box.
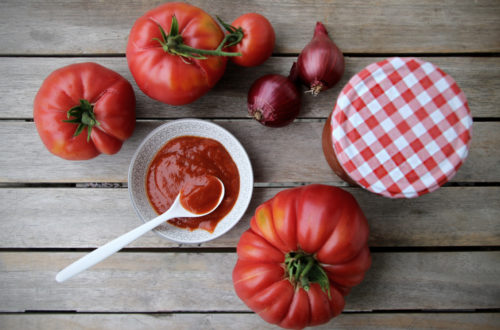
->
(297, 22), (344, 95)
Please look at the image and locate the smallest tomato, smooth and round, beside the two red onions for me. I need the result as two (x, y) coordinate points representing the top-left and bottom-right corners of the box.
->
(217, 13), (276, 67)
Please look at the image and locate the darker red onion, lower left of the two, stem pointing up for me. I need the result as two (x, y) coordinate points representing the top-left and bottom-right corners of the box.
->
(247, 63), (301, 127)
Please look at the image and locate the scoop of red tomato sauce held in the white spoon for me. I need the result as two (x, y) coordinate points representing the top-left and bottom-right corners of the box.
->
(180, 175), (222, 214)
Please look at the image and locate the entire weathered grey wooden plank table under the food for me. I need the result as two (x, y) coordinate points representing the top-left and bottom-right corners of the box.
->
(0, 0), (500, 329)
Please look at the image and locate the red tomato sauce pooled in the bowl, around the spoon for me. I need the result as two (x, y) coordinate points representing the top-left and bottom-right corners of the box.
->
(146, 136), (240, 232)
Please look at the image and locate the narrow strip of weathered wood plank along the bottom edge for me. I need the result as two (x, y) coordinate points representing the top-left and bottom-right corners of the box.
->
(0, 313), (500, 330)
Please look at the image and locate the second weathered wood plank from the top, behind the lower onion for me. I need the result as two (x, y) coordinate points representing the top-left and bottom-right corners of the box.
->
(0, 57), (500, 119)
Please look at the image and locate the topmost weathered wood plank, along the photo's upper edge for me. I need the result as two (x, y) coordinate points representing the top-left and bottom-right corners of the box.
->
(0, 0), (500, 54)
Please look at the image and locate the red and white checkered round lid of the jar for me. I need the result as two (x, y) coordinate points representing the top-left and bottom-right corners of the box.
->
(330, 57), (472, 198)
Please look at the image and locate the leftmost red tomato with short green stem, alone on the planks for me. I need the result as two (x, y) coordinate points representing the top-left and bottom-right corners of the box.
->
(33, 63), (135, 160)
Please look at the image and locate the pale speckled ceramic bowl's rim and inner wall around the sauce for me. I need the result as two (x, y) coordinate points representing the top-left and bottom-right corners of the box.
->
(128, 119), (253, 244)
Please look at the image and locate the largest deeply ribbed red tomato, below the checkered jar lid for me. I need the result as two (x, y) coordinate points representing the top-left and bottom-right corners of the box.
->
(233, 185), (371, 328)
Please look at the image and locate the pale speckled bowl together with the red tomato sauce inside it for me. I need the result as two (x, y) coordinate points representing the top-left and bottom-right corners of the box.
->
(128, 119), (253, 244)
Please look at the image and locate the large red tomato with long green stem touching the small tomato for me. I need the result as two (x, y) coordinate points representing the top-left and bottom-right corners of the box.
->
(127, 2), (226, 105)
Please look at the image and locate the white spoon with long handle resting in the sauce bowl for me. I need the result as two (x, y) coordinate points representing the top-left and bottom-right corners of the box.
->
(56, 179), (224, 282)
